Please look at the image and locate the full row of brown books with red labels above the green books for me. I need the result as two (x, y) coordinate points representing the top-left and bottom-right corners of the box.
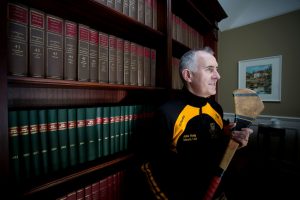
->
(8, 3), (156, 87)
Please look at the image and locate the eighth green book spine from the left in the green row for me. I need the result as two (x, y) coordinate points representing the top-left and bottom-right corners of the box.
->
(77, 108), (86, 163)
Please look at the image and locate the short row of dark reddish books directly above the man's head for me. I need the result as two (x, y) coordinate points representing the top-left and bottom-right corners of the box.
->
(172, 14), (203, 49)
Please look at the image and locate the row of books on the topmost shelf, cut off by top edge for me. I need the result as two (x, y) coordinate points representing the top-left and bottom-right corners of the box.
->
(94, 0), (157, 30)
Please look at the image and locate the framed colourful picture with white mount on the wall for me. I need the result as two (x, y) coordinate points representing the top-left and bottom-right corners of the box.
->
(238, 55), (282, 101)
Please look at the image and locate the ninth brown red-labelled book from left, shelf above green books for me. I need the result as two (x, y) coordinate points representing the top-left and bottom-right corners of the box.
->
(117, 38), (124, 85)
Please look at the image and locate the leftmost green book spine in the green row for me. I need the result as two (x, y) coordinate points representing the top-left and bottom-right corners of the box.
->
(8, 111), (21, 183)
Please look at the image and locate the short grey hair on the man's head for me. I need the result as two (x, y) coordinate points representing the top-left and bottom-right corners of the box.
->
(179, 46), (214, 81)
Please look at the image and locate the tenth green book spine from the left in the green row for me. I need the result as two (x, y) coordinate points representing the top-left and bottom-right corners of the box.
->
(96, 107), (103, 158)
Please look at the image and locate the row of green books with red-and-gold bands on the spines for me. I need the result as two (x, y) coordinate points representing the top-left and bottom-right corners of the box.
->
(8, 104), (152, 183)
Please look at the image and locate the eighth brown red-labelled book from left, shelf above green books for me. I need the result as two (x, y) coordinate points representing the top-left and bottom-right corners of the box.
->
(108, 35), (117, 84)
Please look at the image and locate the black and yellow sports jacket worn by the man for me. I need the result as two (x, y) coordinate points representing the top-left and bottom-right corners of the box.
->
(142, 88), (229, 200)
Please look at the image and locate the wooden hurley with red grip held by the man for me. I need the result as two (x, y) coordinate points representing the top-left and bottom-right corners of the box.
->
(203, 88), (264, 200)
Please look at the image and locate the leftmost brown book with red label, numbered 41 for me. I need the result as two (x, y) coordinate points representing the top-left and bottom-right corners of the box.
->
(7, 3), (28, 76)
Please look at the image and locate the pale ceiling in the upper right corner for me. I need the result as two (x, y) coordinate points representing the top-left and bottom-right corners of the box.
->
(218, 0), (300, 31)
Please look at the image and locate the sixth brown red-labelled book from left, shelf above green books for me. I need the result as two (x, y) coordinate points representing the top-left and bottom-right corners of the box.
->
(89, 28), (99, 82)
